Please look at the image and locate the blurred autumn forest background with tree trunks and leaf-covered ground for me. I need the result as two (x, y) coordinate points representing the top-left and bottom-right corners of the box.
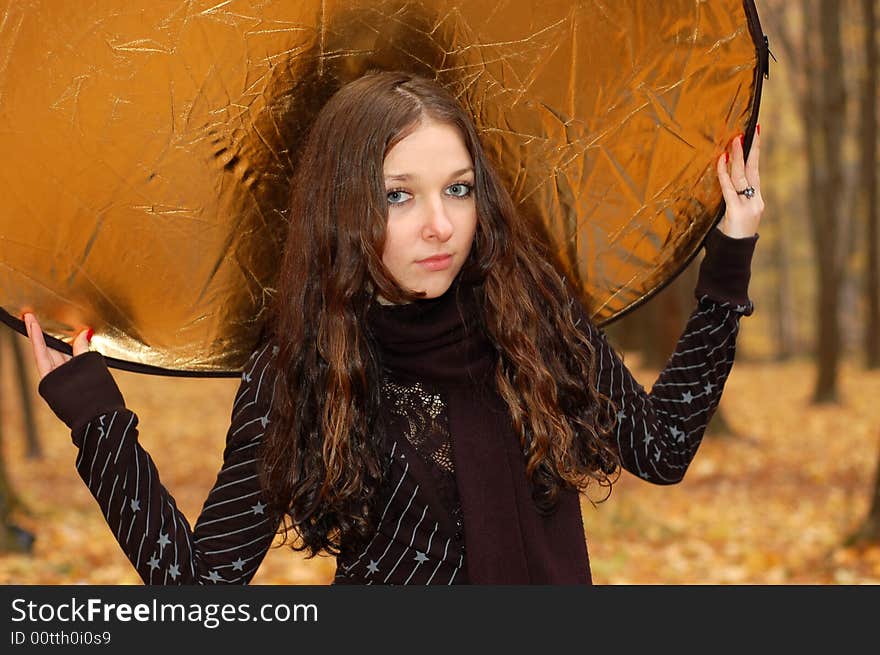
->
(0, 0), (880, 584)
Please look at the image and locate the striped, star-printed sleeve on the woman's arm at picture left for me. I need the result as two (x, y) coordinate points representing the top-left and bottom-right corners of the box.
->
(40, 345), (277, 585)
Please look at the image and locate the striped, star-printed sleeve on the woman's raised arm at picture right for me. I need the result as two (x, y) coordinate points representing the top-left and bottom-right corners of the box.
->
(576, 229), (758, 484)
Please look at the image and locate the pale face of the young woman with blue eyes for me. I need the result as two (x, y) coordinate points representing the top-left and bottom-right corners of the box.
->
(382, 119), (477, 298)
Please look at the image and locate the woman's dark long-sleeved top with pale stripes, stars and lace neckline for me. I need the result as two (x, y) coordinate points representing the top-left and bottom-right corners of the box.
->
(39, 229), (758, 584)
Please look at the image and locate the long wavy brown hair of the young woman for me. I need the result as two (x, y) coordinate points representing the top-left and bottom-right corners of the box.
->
(260, 72), (619, 556)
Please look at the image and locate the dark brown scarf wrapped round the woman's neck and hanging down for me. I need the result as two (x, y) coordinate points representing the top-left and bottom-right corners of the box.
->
(368, 278), (591, 584)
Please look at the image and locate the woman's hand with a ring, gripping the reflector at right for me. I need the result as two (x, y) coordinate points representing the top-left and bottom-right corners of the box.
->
(717, 125), (764, 239)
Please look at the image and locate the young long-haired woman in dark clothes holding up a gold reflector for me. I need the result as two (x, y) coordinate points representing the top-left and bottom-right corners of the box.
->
(26, 73), (763, 584)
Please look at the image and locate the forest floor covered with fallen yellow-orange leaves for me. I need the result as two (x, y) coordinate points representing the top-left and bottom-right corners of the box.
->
(0, 348), (880, 584)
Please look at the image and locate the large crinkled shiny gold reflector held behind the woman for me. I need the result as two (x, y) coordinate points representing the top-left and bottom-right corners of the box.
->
(0, 0), (763, 375)
